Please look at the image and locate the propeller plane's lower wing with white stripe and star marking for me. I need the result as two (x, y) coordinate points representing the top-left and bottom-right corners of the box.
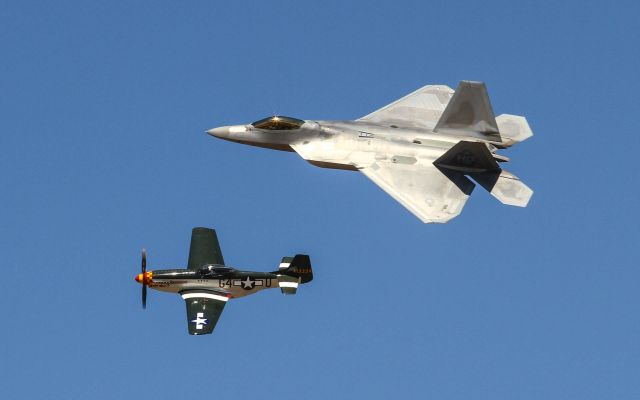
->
(181, 290), (229, 335)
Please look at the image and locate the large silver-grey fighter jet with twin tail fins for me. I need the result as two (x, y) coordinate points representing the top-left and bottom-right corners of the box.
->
(207, 81), (533, 223)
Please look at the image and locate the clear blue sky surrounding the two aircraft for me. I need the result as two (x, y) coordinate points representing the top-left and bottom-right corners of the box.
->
(0, 1), (640, 399)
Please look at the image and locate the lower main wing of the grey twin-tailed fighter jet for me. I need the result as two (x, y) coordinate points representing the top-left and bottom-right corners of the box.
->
(360, 160), (475, 223)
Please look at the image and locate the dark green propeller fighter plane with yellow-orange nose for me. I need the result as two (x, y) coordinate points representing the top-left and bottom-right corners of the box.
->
(135, 228), (313, 335)
